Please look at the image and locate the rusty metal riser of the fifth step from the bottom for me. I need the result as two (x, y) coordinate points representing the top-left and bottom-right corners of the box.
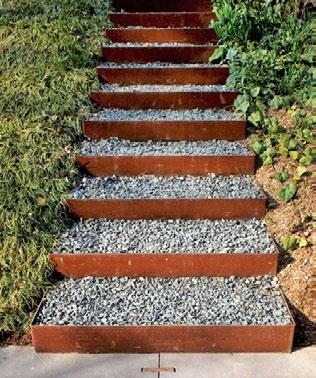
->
(83, 120), (246, 141)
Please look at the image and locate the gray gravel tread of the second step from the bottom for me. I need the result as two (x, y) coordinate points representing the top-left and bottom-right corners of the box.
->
(57, 219), (275, 253)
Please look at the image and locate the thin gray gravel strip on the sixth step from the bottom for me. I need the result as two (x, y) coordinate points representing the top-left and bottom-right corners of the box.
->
(102, 84), (235, 92)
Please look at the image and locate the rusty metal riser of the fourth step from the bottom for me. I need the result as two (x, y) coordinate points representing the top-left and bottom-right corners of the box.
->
(76, 154), (255, 176)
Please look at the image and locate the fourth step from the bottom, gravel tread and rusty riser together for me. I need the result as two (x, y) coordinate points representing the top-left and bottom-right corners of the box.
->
(76, 138), (255, 176)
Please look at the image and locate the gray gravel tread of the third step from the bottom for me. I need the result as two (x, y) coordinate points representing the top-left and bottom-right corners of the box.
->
(72, 174), (262, 199)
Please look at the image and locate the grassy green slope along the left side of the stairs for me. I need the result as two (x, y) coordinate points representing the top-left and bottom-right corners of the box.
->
(0, 0), (110, 336)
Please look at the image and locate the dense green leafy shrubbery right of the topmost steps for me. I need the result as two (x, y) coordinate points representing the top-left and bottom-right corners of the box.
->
(211, 0), (311, 111)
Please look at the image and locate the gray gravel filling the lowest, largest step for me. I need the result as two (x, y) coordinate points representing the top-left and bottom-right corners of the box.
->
(36, 276), (291, 326)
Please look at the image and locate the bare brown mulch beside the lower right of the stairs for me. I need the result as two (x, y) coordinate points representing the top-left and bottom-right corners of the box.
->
(255, 158), (313, 347)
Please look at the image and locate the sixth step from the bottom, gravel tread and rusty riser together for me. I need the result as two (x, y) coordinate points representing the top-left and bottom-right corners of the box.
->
(91, 84), (238, 109)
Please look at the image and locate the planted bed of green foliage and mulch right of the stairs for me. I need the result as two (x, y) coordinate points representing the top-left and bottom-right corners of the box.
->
(211, 0), (313, 345)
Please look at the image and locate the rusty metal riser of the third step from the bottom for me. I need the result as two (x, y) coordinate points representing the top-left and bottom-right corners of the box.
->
(65, 198), (266, 219)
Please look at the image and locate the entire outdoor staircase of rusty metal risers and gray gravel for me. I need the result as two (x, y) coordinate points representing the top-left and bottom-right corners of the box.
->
(32, 0), (295, 353)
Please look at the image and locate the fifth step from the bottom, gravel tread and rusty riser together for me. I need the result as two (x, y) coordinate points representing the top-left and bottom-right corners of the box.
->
(83, 109), (246, 141)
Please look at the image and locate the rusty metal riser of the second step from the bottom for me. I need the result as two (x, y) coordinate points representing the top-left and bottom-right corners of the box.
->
(50, 253), (278, 278)
